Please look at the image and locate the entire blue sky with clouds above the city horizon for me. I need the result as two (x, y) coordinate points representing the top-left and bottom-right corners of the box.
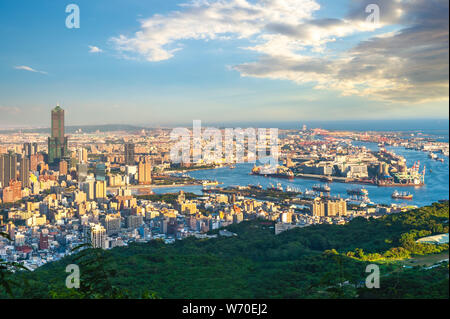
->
(0, 0), (449, 128)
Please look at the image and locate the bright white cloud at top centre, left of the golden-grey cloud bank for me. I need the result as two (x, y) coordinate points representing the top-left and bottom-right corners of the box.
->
(111, 0), (320, 62)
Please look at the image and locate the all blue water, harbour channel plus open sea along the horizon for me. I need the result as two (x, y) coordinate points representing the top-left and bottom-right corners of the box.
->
(138, 118), (449, 206)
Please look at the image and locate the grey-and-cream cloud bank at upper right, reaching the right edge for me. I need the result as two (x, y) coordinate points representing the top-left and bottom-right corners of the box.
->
(234, 0), (449, 103)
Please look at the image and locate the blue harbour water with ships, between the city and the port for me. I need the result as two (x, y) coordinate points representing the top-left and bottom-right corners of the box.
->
(153, 142), (449, 207)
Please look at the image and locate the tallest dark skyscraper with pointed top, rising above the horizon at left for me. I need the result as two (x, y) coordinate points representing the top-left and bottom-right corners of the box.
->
(48, 105), (69, 166)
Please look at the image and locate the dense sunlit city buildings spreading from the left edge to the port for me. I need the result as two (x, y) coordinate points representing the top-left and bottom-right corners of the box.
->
(0, 105), (448, 269)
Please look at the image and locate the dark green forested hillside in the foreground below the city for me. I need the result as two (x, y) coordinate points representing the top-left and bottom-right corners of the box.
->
(0, 202), (449, 298)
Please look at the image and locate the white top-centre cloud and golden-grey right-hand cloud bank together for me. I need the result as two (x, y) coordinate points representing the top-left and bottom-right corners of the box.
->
(111, 0), (448, 103)
